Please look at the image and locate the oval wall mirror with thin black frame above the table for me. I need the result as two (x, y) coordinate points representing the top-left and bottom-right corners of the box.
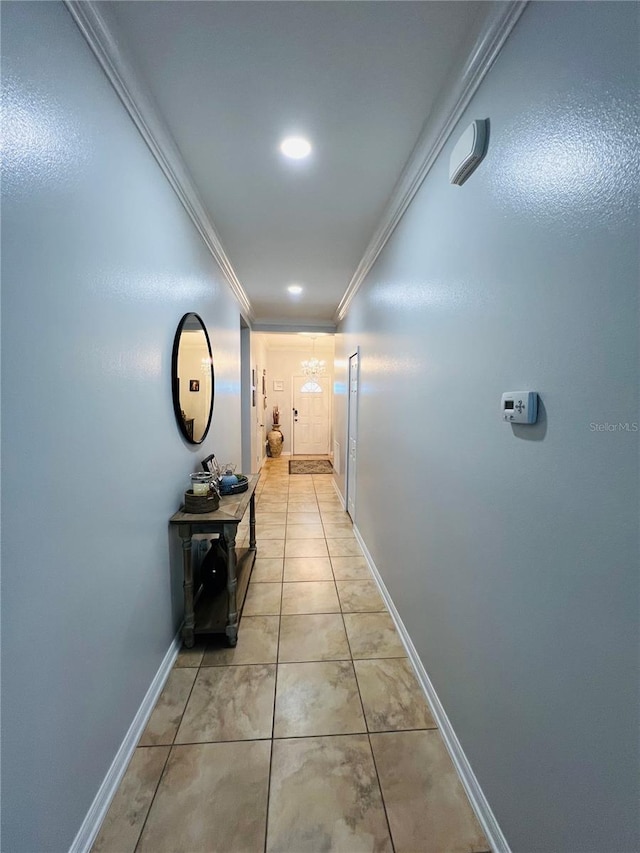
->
(171, 314), (215, 444)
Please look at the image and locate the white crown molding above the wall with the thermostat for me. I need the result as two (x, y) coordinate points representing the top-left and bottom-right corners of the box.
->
(334, 0), (528, 323)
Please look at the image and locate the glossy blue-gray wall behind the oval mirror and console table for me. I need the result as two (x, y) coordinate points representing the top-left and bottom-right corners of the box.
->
(2, 3), (240, 853)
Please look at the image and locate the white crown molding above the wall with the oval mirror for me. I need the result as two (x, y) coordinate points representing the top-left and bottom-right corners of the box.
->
(63, 0), (253, 320)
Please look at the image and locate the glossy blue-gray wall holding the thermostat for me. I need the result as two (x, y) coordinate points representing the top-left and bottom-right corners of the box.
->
(336, 3), (640, 853)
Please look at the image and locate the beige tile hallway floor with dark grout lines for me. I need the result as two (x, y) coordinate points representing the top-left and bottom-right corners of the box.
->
(93, 458), (489, 853)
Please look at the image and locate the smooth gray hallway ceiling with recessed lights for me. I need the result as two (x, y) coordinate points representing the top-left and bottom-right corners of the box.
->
(97, 0), (491, 328)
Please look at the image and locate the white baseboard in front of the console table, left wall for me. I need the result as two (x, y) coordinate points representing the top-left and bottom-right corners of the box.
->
(69, 631), (182, 853)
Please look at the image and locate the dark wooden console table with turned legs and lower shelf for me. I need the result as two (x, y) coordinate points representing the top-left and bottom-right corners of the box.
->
(169, 474), (260, 649)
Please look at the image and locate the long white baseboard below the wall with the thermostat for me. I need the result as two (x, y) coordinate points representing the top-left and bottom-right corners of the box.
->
(352, 524), (511, 853)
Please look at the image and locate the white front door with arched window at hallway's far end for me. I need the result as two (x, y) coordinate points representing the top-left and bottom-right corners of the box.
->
(293, 376), (329, 456)
